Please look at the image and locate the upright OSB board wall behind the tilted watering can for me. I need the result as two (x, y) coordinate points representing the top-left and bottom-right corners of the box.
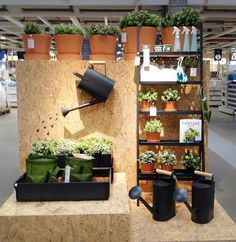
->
(17, 61), (209, 184)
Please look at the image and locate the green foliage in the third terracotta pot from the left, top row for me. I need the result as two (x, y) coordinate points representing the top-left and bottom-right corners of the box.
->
(85, 24), (120, 36)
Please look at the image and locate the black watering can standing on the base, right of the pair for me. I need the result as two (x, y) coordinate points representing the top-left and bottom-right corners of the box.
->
(174, 171), (215, 224)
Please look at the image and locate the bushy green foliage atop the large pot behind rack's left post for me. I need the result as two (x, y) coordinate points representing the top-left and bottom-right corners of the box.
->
(119, 10), (161, 29)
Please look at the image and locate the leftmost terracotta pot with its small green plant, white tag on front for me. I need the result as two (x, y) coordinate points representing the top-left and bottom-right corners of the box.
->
(23, 22), (51, 60)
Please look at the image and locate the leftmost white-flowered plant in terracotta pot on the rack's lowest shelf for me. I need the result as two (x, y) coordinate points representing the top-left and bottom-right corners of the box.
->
(139, 150), (158, 173)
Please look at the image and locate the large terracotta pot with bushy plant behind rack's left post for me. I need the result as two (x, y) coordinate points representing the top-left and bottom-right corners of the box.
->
(120, 10), (160, 60)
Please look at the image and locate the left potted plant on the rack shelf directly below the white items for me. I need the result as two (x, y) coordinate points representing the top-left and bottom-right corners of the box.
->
(138, 88), (158, 111)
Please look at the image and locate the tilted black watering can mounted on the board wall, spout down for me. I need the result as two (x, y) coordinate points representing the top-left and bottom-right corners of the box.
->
(61, 64), (115, 117)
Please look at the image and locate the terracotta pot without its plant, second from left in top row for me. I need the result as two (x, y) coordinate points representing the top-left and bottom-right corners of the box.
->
(55, 34), (83, 60)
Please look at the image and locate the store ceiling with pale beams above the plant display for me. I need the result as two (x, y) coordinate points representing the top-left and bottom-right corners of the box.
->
(0, 0), (236, 51)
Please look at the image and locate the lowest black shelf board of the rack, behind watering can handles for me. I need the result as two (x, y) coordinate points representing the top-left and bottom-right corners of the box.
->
(138, 169), (201, 181)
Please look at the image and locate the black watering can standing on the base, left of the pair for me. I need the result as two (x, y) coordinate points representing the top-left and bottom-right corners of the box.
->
(129, 169), (176, 221)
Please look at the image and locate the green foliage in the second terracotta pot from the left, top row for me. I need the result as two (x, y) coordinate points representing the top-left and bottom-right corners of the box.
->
(53, 23), (84, 36)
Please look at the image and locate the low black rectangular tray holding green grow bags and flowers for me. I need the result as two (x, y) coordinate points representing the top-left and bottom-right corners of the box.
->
(14, 168), (110, 201)
